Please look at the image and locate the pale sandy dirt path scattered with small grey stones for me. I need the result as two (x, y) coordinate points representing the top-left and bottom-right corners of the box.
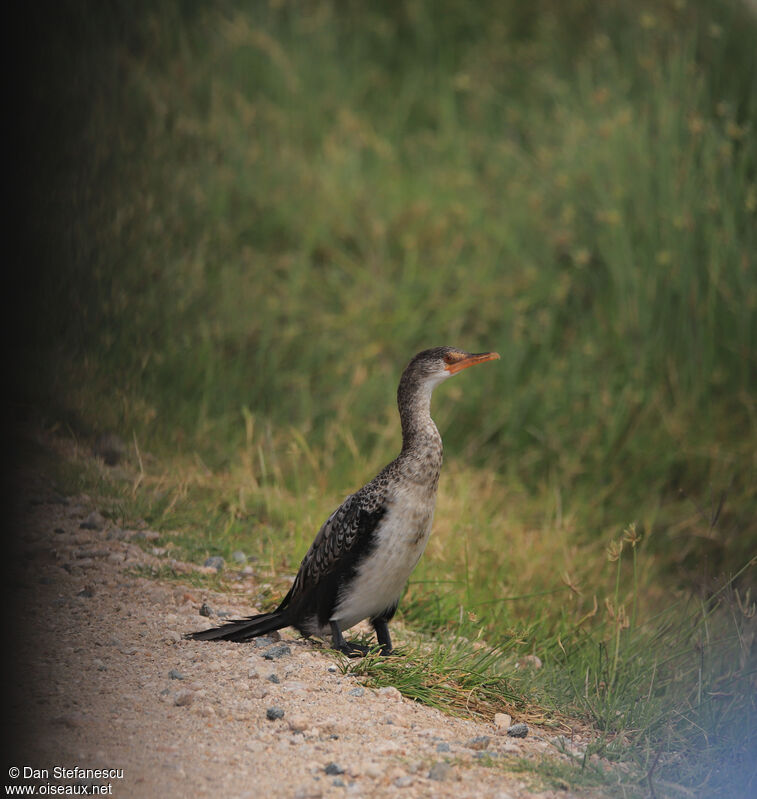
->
(4, 454), (584, 799)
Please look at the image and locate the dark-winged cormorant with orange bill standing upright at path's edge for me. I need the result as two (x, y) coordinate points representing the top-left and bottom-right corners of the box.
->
(186, 347), (499, 657)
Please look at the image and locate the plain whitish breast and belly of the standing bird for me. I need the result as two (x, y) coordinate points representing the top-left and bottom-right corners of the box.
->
(332, 485), (436, 630)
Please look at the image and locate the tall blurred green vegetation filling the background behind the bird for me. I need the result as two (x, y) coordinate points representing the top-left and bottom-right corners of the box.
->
(13, 0), (757, 792)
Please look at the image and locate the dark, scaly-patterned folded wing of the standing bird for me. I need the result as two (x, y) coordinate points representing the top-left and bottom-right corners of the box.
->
(280, 491), (385, 607)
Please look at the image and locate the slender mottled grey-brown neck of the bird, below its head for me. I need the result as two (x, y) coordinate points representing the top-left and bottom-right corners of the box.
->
(397, 383), (442, 488)
